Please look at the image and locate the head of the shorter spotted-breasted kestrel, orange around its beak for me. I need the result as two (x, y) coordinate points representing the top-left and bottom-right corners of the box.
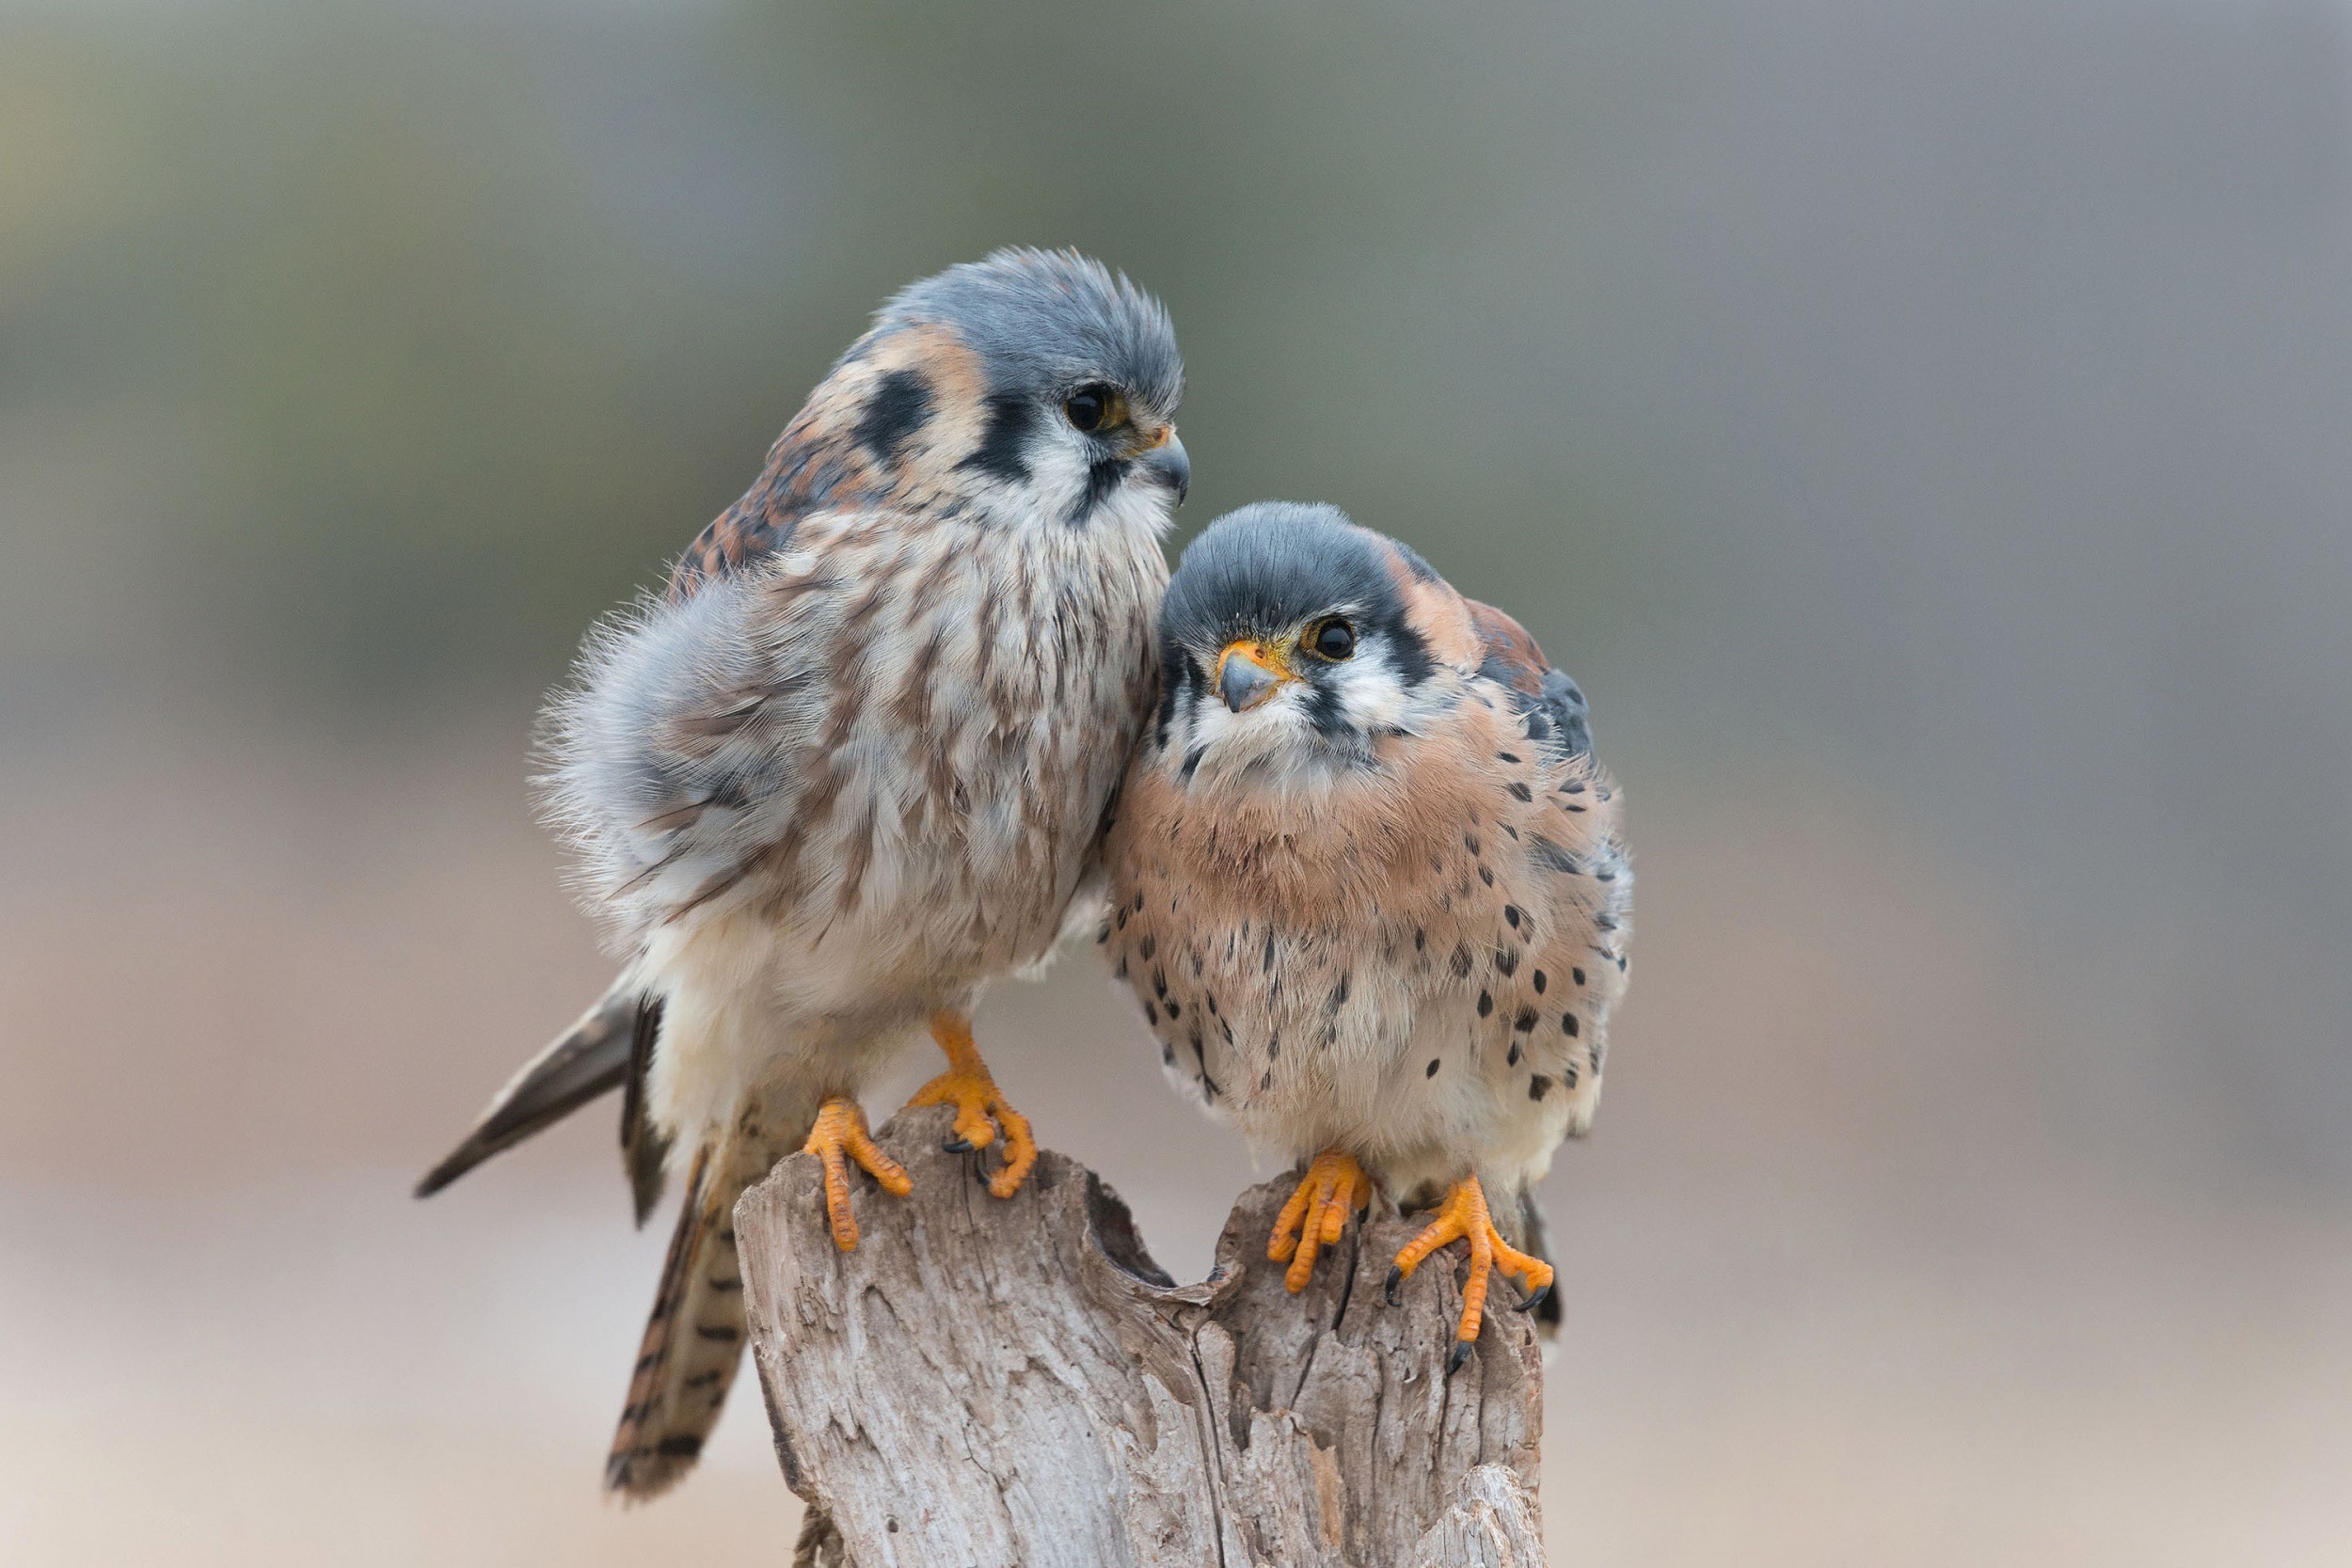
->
(1160, 500), (1475, 778)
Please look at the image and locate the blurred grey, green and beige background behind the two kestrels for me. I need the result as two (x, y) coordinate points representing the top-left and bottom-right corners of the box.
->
(0, 0), (2352, 1568)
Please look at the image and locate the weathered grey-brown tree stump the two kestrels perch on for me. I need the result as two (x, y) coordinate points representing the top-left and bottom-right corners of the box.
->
(737, 1110), (1543, 1568)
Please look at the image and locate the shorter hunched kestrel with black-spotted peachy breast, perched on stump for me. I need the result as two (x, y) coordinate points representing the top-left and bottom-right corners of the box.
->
(1099, 503), (1632, 1369)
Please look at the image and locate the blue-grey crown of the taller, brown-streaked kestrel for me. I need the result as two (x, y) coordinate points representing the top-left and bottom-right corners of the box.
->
(875, 246), (1184, 419)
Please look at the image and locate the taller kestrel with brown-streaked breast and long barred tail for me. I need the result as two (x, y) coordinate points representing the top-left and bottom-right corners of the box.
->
(421, 249), (1188, 1497)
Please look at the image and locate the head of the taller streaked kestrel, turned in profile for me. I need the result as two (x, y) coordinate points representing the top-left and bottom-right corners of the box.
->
(812, 249), (1193, 529)
